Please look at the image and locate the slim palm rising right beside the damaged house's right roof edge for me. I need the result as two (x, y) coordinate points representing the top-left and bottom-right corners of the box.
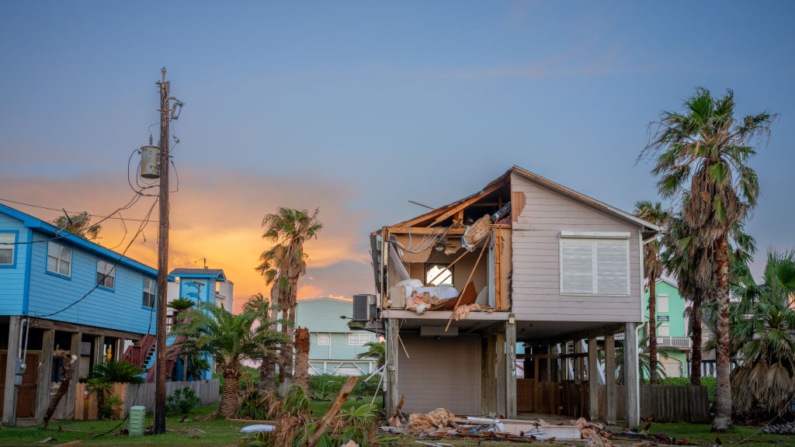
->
(635, 201), (671, 385)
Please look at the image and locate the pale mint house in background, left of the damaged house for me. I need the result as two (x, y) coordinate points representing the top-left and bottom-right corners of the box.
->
(295, 298), (377, 376)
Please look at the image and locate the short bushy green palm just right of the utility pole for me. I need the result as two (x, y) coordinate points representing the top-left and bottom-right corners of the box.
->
(169, 303), (284, 417)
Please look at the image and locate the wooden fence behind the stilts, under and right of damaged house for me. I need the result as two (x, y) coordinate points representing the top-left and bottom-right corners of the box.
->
(516, 379), (709, 423)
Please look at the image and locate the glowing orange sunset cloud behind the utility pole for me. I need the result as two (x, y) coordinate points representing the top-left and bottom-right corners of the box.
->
(0, 169), (372, 316)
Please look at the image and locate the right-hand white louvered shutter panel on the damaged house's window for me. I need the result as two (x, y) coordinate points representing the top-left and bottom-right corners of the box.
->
(594, 239), (629, 295)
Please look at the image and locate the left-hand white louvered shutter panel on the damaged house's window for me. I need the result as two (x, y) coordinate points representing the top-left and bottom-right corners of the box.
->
(560, 238), (594, 294)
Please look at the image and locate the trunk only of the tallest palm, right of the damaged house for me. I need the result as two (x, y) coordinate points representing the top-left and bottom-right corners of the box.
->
(712, 236), (732, 432)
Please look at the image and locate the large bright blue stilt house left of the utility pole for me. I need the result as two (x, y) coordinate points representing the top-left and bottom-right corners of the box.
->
(0, 204), (163, 425)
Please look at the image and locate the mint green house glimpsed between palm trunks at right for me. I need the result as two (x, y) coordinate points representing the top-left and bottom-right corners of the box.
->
(643, 279), (691, 377)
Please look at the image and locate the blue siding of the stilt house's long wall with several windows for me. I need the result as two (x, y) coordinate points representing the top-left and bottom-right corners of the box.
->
(28, 232), (155, 333)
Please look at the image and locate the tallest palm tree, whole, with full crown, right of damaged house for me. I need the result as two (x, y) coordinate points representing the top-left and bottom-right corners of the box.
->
(641, 88), (775, 431)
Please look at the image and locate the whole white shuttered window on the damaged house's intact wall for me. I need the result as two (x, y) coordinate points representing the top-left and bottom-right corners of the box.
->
(560, 231), (629, 295)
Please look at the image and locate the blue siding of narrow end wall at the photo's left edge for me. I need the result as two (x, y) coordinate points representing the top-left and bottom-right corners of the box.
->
(0, 214), (30, 315)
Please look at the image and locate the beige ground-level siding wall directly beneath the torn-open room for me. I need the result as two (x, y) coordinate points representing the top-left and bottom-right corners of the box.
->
(398, 333), (481, 416)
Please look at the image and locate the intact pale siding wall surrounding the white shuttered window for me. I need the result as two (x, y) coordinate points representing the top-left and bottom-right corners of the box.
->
(511, 175), (641, 322)
